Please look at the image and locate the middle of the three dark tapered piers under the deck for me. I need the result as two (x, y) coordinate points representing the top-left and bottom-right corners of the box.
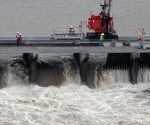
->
(73, 53), (89, 84)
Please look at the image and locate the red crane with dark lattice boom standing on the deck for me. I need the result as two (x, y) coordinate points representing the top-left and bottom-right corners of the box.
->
(87, 0), (118, 39)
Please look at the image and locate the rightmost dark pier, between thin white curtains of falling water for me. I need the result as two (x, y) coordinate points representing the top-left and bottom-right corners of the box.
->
(129, 53), (140, 84)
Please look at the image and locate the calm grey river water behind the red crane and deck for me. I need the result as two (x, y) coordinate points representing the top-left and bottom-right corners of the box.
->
(0, 0), (150, 36)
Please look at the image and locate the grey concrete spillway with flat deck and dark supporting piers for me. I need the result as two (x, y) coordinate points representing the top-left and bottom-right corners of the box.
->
(0, 37), (150, 84)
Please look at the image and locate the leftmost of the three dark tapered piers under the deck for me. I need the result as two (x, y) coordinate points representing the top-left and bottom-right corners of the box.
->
(23, 53), (38, 83)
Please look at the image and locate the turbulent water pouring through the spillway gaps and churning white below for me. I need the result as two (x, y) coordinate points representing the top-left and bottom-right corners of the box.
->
(0, 55), (150, 125)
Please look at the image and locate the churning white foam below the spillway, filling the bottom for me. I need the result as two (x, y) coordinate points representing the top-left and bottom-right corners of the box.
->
(0, 83), (150, 125)
